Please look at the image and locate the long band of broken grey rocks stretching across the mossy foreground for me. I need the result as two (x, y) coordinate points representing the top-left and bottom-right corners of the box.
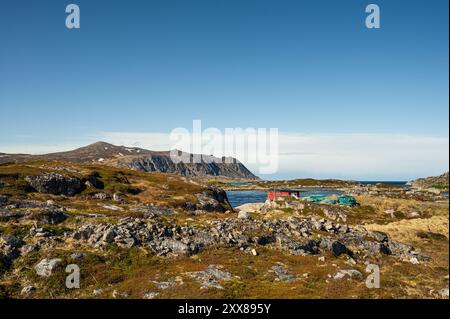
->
(72, 217), (428, 262)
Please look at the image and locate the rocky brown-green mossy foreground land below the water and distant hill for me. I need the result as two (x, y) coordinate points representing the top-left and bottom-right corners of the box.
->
(0, 162), (448, 299)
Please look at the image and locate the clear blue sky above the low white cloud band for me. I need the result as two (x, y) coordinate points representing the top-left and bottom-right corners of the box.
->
(0, 0), (449, 178)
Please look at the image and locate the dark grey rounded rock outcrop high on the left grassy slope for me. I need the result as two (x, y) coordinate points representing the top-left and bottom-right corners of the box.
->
(25, 173), (85, 196)
